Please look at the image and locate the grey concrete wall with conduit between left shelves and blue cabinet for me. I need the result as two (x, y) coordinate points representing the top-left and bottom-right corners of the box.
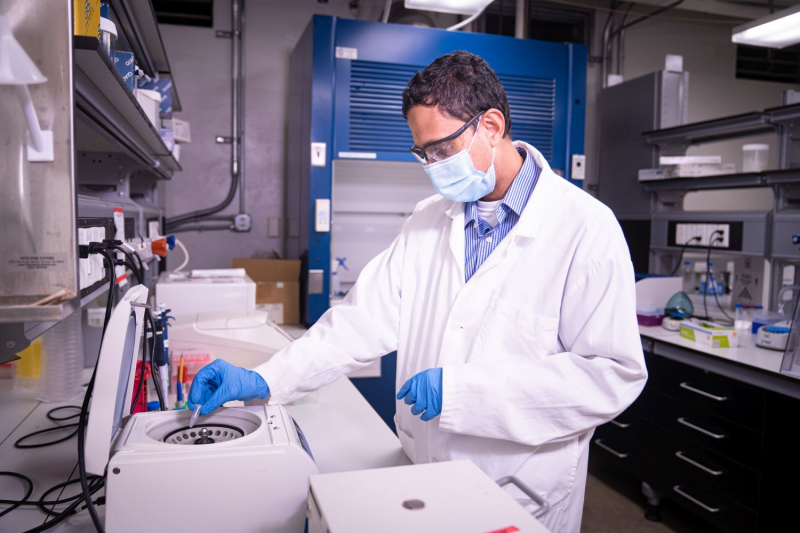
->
(160, 0), (453, 269)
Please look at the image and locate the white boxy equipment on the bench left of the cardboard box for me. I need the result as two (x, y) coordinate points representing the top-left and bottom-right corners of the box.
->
(156, 268), (256, 317)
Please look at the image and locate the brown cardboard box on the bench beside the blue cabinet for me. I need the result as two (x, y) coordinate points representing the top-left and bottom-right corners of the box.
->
(233, 258), (300, 324)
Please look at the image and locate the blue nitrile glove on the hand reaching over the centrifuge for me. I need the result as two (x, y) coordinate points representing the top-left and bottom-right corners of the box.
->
(189, 359), (269, 416)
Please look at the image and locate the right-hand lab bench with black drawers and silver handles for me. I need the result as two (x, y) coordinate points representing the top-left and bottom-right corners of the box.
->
(590, 326), (800, 532)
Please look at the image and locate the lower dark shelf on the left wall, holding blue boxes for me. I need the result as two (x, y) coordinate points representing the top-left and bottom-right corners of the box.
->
(74, 36), (181, 179)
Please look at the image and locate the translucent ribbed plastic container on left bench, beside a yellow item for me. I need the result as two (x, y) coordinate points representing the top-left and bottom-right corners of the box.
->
(37, 311), (83, 402)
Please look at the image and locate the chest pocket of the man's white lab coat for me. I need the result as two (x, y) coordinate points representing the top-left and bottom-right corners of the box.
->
(470, 296), (558, 363)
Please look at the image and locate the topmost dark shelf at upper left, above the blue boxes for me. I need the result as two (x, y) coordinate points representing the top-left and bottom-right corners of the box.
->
(109, 0), (181, 111)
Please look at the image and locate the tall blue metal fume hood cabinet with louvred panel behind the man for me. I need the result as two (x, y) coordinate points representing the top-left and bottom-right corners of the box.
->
(286, 15), (587, 324)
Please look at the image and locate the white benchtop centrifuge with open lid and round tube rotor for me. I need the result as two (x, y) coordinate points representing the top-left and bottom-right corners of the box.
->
(85, 286), (317, 533)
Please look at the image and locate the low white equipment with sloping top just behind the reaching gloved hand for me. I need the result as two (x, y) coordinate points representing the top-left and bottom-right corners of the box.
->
(169, 311), (292, 368)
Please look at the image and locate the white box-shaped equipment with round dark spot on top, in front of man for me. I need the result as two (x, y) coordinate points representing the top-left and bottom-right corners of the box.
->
(308, 461), (548, 533)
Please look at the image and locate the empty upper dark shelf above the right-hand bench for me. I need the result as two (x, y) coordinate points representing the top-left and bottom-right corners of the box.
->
(642, 112), (775, 146)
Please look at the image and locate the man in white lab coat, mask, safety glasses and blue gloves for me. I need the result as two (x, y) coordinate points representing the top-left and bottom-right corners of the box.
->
(190, 52), (647, 533)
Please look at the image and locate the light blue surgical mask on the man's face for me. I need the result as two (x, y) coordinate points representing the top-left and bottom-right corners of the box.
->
(422, 122), (495, 202)
